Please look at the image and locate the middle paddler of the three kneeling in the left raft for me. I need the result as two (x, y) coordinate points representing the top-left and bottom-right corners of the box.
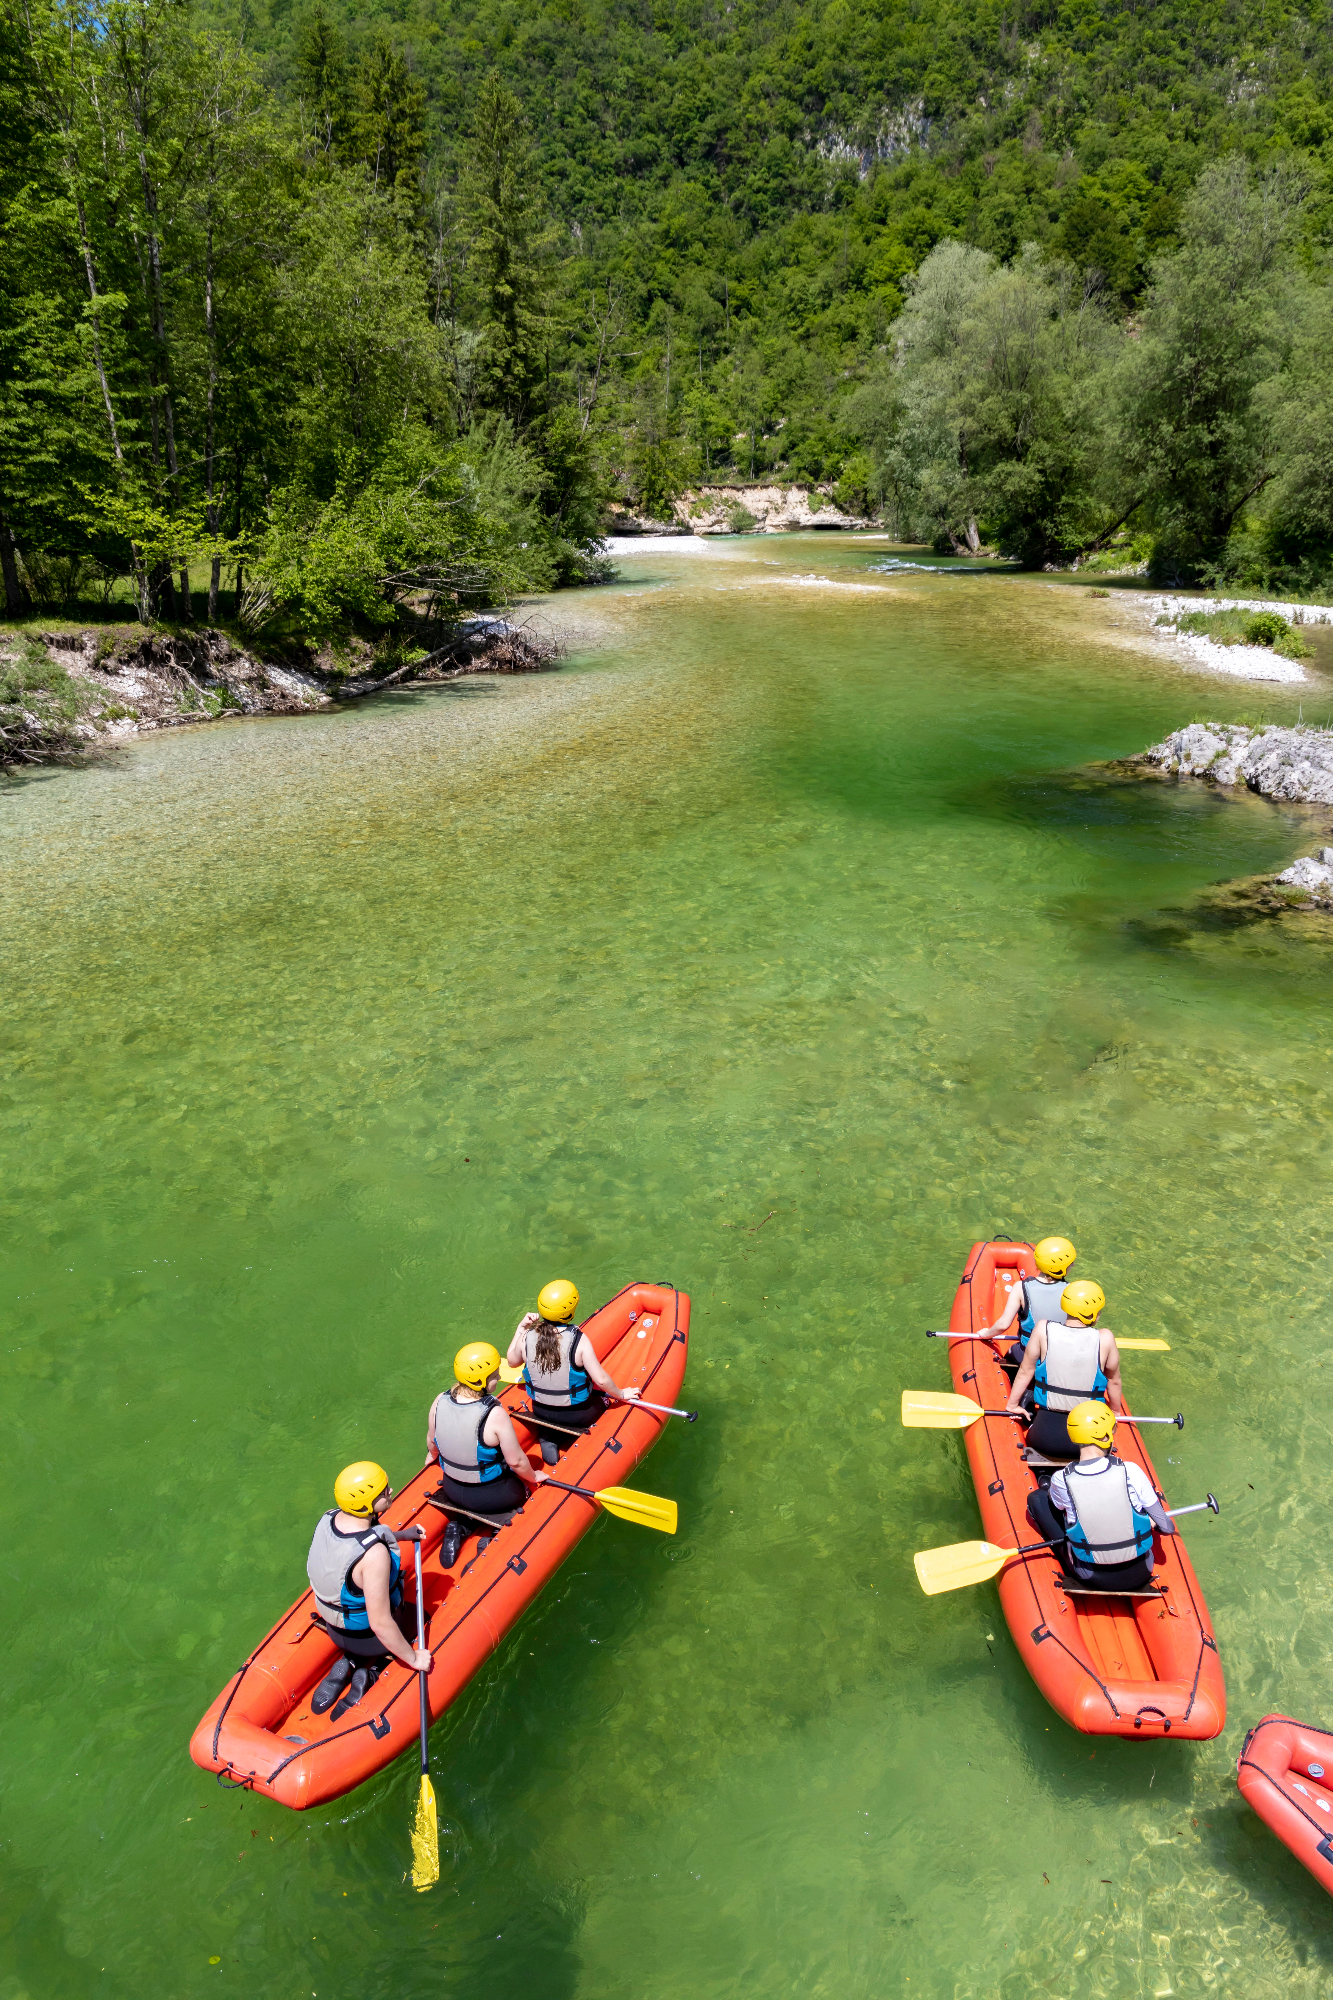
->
(426, 1340), (546, 1570)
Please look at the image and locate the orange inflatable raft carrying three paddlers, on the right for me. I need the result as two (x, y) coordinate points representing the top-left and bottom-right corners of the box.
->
(949, 1242), (1227, 1740)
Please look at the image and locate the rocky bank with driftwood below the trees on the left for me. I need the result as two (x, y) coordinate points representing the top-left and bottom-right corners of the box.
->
(0, 616), (560, 768)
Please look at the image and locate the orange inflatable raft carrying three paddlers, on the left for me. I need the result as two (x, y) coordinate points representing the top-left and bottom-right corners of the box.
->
(190, 1284), (691, 1810)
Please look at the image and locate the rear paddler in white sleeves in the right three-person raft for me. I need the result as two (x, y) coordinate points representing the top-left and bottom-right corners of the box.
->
(1027, 1402), (1175, 1590)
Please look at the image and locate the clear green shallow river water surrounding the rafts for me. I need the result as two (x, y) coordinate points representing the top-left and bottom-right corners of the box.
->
(0, 538), (1333, 2000)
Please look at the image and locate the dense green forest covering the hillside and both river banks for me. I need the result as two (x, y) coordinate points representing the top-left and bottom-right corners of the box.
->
(0, 0), (1333, 642)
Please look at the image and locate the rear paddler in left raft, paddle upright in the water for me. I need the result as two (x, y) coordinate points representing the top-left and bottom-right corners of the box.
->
(306, 1458), (430, 1722)
